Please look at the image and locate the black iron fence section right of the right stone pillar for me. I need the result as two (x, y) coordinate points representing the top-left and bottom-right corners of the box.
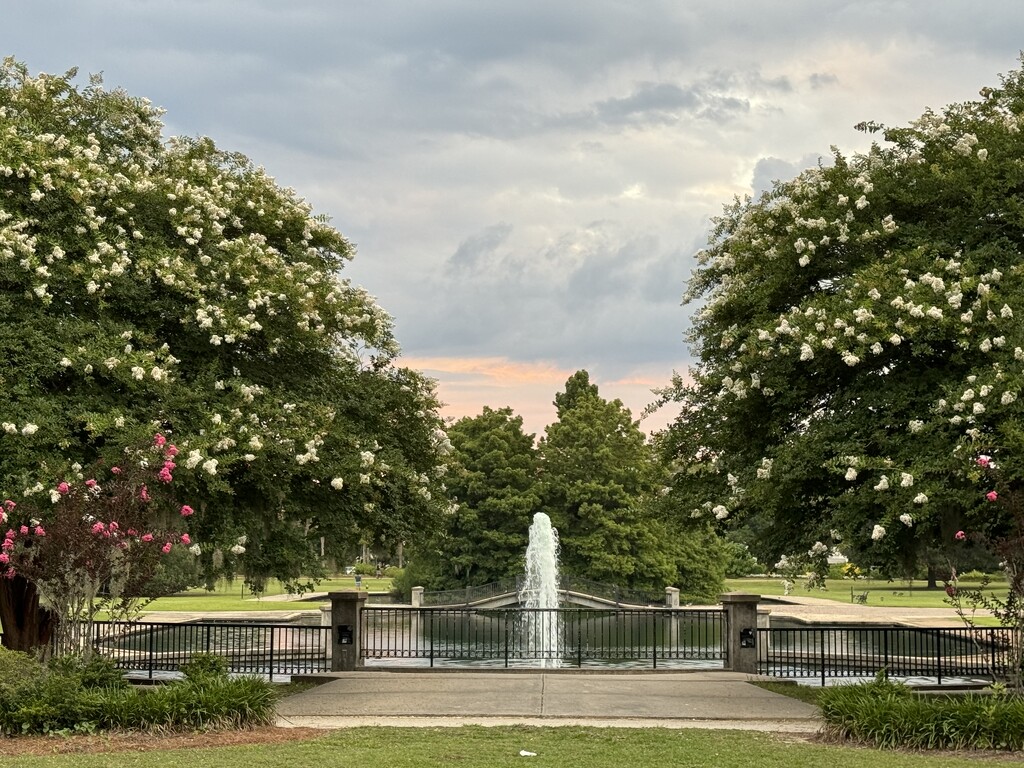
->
(758, 625), (1015, 685)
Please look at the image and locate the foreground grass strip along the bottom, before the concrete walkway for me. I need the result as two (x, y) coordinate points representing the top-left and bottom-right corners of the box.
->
(3, 726), (1007, 768)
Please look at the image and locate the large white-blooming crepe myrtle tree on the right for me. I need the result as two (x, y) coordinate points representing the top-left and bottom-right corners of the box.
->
(666, 61), (1024, 568)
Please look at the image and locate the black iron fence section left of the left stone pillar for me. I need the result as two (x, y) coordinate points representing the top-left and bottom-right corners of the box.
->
(92, 622), (331, 682)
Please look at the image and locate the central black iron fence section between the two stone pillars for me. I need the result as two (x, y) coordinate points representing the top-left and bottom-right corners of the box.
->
(360, 605), (726, 669)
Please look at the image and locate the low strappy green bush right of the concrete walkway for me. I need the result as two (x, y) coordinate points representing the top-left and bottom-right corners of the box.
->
(819, 677), (1024, 750)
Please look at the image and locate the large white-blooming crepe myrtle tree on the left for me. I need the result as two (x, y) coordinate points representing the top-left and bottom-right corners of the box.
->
(0, 58), (445, 643)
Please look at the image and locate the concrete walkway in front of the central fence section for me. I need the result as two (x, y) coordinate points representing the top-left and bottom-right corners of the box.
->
(278, 670), (820, 733)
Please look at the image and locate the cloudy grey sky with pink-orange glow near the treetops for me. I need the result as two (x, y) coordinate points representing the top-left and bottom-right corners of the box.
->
(0, 0), (1024, 434)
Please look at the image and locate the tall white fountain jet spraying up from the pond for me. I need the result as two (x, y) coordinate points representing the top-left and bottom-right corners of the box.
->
(519, 512), (562, 667)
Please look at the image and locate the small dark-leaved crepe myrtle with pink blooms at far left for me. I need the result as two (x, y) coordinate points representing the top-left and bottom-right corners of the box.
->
(0, 433), (195, 655)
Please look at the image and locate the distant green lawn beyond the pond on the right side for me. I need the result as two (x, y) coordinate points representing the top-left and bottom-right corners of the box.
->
(725, 578), (1007, 608)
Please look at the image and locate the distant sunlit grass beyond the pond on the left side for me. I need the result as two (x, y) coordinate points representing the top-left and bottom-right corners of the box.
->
(130, 577), (391, 612)
